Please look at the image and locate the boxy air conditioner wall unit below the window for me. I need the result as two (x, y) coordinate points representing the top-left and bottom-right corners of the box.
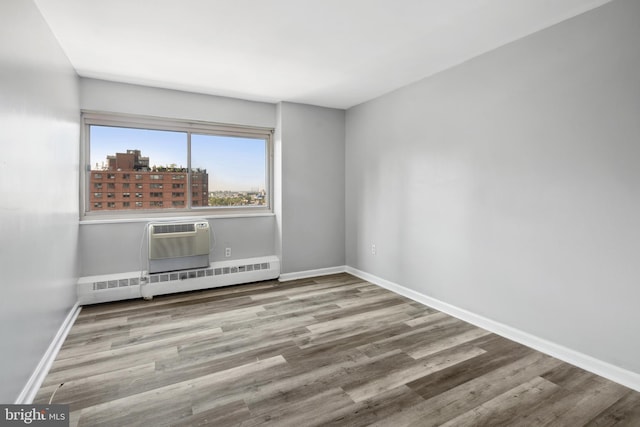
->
(148, 221), (211, 274)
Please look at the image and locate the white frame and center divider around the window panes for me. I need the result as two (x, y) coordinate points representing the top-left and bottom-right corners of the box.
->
(80, 110), (274, 220)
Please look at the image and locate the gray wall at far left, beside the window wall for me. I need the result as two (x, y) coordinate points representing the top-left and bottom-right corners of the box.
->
(0, 0), (80, 403)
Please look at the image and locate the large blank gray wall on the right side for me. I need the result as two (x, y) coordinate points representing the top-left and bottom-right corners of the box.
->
(346, 0), (640, 372)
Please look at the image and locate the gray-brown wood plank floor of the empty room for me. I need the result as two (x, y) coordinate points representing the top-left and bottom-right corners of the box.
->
(35, 274), (640, 427)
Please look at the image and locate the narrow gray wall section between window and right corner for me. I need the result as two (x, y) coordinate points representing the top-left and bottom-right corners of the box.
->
(276, 102), (345, 273)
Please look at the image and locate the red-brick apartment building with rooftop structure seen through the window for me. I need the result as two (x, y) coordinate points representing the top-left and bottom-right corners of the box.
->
(89, 150), (209, 211)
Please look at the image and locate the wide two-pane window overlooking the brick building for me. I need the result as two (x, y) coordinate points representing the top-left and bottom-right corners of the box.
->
(81, 113), (272, 216)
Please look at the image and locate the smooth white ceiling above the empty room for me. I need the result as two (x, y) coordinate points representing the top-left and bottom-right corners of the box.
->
(34, 0), (610, 108)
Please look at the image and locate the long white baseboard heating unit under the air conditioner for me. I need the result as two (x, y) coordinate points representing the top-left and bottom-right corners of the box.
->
(78, 256), (280, 305)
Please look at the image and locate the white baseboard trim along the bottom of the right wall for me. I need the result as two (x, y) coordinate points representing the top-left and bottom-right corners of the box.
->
(345, 266), (640, 391)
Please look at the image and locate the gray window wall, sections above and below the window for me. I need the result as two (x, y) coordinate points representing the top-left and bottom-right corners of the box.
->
(80, 78), (276, 276)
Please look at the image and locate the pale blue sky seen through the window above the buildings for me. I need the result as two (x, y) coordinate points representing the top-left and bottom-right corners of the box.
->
(90, 126), (266, 191)
